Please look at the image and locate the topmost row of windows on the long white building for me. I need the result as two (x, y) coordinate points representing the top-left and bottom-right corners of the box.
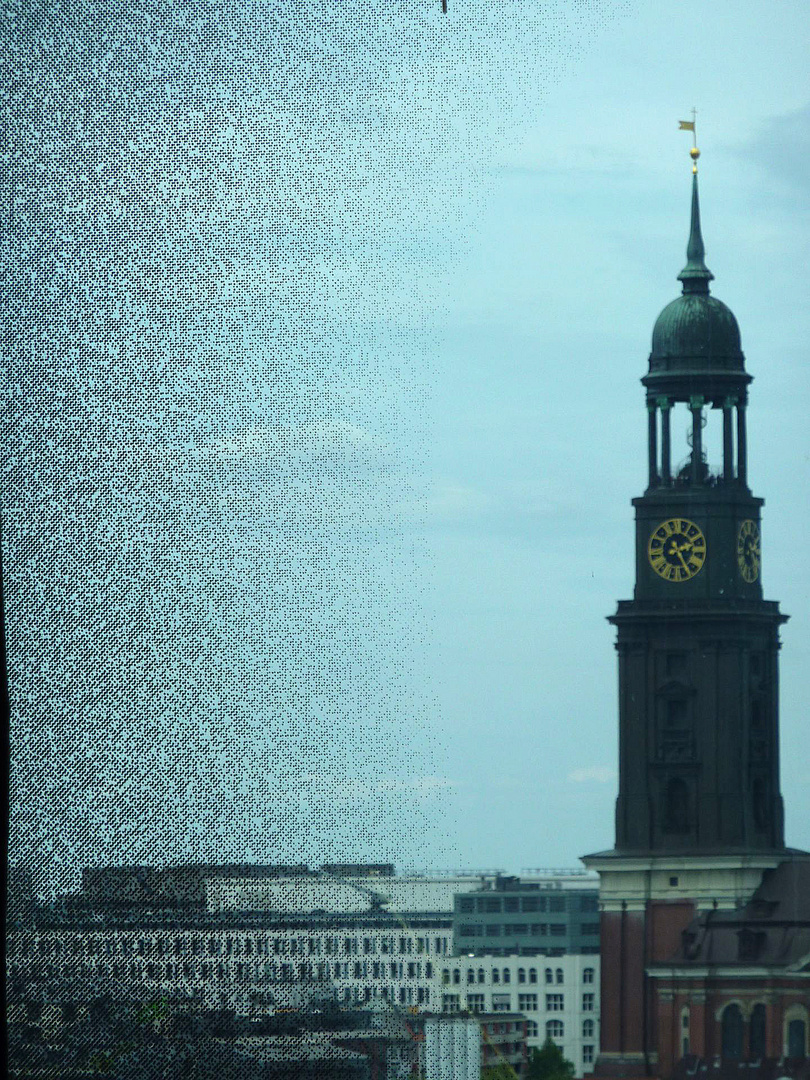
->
(9, 934), (449, 957)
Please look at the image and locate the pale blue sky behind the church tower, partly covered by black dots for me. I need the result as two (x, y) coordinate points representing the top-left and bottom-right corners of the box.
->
(8, 0), (810, 894)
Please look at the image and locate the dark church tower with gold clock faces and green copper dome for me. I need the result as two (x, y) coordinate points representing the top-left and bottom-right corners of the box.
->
(584, 145), (786, 1077)
